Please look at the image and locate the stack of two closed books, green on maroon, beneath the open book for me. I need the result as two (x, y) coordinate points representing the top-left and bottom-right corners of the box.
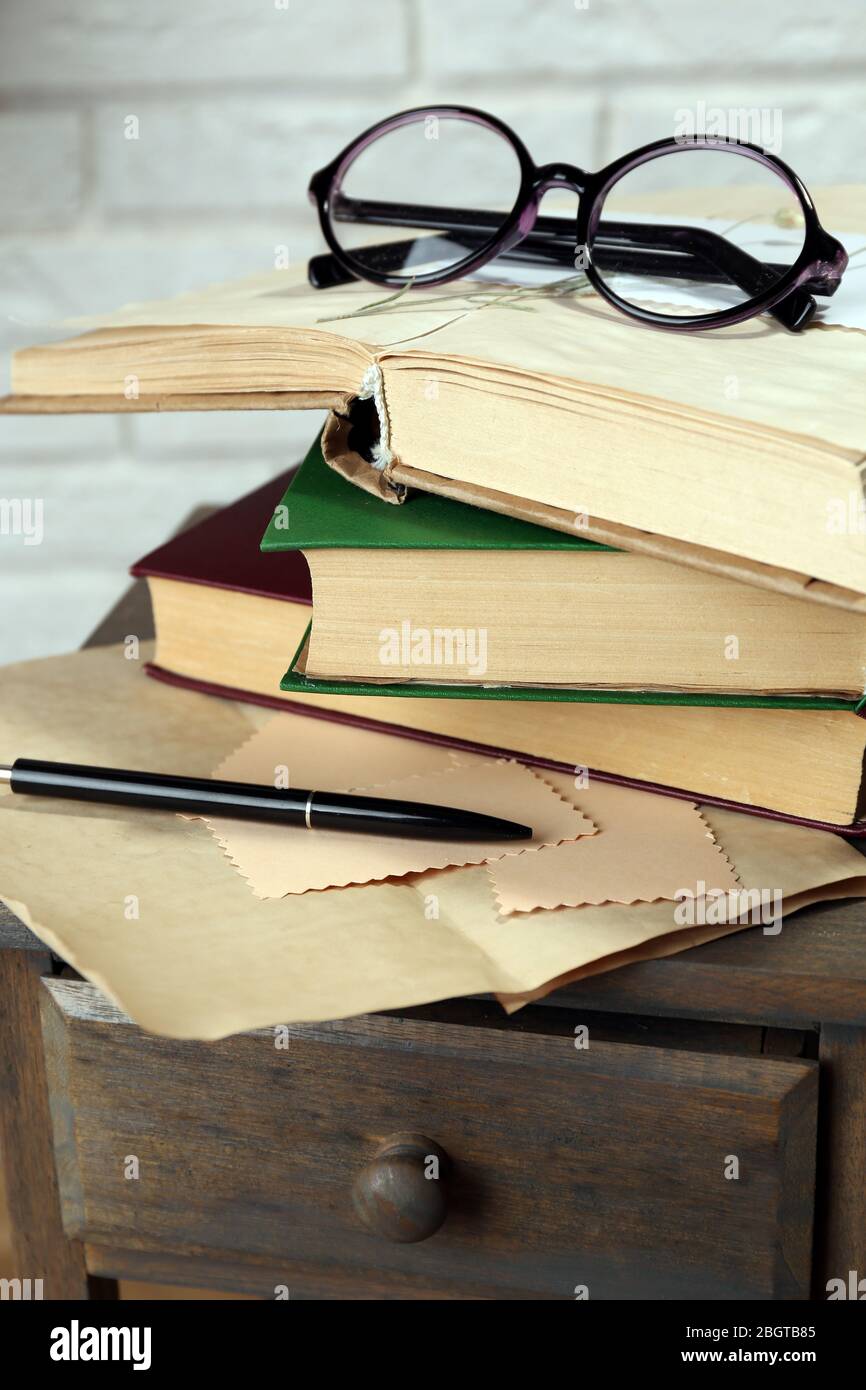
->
(125, 443), (866, 827)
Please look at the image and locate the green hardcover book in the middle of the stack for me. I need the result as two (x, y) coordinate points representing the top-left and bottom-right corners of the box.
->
(261, 448), (866, 709)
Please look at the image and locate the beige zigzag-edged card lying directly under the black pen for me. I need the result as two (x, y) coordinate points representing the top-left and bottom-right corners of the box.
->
(207, 714), (595, 898)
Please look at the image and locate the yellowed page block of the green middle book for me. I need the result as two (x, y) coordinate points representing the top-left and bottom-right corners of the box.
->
(306, 548), (866, 701)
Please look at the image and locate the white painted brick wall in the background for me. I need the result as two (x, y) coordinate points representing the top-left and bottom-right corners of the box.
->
(0, 0), (866, 660)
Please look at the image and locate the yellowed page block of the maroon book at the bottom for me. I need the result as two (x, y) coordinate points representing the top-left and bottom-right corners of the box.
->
(149, 580), (866, 824)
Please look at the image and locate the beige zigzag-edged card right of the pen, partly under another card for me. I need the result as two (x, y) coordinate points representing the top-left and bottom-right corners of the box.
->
(489, 771), (738, 915)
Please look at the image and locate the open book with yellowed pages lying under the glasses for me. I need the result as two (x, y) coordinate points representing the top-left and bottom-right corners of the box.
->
(6, 190), (866, 613)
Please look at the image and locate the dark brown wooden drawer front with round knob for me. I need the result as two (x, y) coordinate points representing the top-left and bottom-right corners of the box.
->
(43, 979), (817, 1300)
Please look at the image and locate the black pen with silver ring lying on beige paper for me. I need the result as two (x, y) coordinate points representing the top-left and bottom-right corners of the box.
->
(0, 758), (532, 840)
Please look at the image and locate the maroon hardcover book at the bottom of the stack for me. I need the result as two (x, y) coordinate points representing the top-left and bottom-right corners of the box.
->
(132, 444), (866, 834)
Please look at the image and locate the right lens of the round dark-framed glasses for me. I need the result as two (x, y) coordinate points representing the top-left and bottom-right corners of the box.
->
(589, 145), (805, 318)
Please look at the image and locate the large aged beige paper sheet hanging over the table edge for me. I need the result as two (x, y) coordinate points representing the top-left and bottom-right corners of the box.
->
(0, 648), (866, 1038)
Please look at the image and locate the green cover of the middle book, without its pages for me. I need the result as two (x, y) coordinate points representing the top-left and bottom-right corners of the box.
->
(261, 441), (866, 713)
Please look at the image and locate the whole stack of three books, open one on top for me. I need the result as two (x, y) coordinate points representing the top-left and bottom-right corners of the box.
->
(6, 252), (866, 833)
